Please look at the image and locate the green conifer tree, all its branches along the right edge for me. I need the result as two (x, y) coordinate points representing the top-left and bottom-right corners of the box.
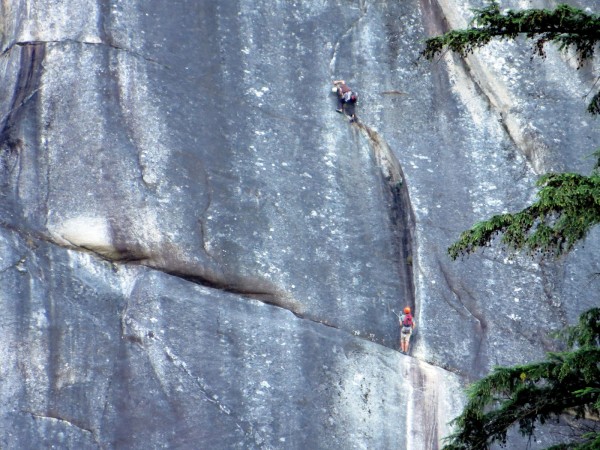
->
(423, 1), (600, 450)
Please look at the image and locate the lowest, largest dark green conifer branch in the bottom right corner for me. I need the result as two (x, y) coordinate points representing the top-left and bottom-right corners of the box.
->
(443, 308), (600, 450)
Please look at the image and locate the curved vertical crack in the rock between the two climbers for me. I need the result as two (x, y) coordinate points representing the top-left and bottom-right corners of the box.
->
(355, 122), (416, 316)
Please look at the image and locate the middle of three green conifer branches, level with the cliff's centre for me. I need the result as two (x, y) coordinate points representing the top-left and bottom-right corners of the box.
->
(448, 172), (600, 259)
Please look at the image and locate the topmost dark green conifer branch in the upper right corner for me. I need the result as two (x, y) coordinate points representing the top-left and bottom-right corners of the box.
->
(422, 1), (600, 114)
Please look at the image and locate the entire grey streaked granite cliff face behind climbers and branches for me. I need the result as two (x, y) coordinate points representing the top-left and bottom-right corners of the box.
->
(0, 0), (600, 449)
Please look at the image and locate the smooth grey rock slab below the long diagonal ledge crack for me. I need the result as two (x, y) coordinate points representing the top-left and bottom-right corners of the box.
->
(0, 237), (462, 448)
